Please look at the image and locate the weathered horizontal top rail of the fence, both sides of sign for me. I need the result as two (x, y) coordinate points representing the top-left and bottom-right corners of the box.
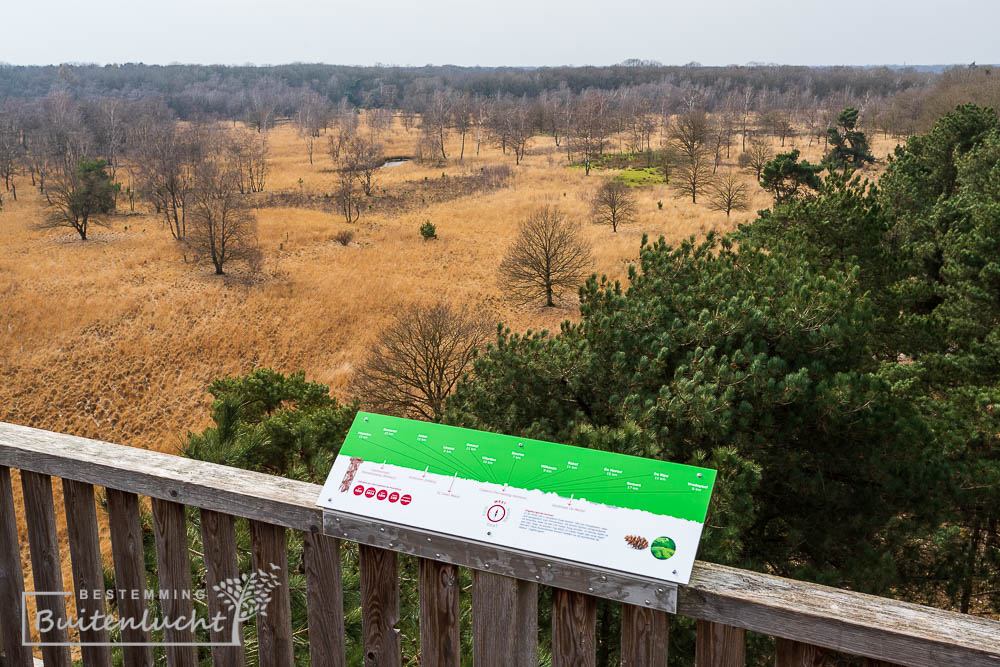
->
(0, 423), (1000, 667)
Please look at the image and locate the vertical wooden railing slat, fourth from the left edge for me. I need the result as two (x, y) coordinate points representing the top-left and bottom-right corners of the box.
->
(106, 489), (153, 665)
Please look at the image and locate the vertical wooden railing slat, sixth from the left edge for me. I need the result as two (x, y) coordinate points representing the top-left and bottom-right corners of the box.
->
(201, 509), (246, 667)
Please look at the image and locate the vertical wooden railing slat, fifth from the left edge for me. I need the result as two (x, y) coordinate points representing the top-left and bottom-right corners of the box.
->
(153, 498), (198, 667)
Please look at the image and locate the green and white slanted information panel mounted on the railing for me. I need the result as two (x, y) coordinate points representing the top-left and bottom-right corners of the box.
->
(318, 412), (715, 583)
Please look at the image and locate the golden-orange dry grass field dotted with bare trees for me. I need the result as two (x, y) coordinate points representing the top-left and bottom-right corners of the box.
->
(0, 116), (894, 636)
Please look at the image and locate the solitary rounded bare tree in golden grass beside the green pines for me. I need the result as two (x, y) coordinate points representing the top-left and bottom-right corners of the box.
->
(500, 206), (591, 306)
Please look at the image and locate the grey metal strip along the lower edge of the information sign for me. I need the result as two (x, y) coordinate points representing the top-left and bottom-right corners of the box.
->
(323, 510), (677, 614)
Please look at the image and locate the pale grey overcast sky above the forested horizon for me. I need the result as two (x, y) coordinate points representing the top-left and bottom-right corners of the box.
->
(0, 0), (1000, 65)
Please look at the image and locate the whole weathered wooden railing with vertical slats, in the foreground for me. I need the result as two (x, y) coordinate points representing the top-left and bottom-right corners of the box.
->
(0, 423), (1000, 667)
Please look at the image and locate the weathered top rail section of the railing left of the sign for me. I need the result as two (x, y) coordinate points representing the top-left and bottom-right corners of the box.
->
(0, 422), (322, 531)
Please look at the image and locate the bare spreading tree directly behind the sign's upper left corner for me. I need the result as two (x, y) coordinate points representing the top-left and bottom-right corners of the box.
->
(355, 303), (493, 421)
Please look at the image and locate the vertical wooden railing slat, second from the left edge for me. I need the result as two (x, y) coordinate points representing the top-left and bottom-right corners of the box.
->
(21, 470), (70, 667)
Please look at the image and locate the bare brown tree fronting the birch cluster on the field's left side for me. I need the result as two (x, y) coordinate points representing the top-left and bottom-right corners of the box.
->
(185, 159), (260, 275)
